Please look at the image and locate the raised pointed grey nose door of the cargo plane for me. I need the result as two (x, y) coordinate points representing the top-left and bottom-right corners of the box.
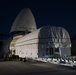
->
(10, 8), (36, 33)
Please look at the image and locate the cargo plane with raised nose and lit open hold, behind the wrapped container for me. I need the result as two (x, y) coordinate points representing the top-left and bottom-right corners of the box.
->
(2, 8), (37, 52)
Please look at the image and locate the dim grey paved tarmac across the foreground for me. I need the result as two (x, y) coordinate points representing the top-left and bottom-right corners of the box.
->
(0, 61), (76, 75)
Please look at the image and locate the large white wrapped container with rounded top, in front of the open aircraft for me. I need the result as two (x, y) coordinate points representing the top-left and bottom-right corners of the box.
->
(15, 26), (71, 58)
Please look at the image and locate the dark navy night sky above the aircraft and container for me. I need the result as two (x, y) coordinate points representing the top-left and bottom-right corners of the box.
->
(0, 0), (76, 36)
